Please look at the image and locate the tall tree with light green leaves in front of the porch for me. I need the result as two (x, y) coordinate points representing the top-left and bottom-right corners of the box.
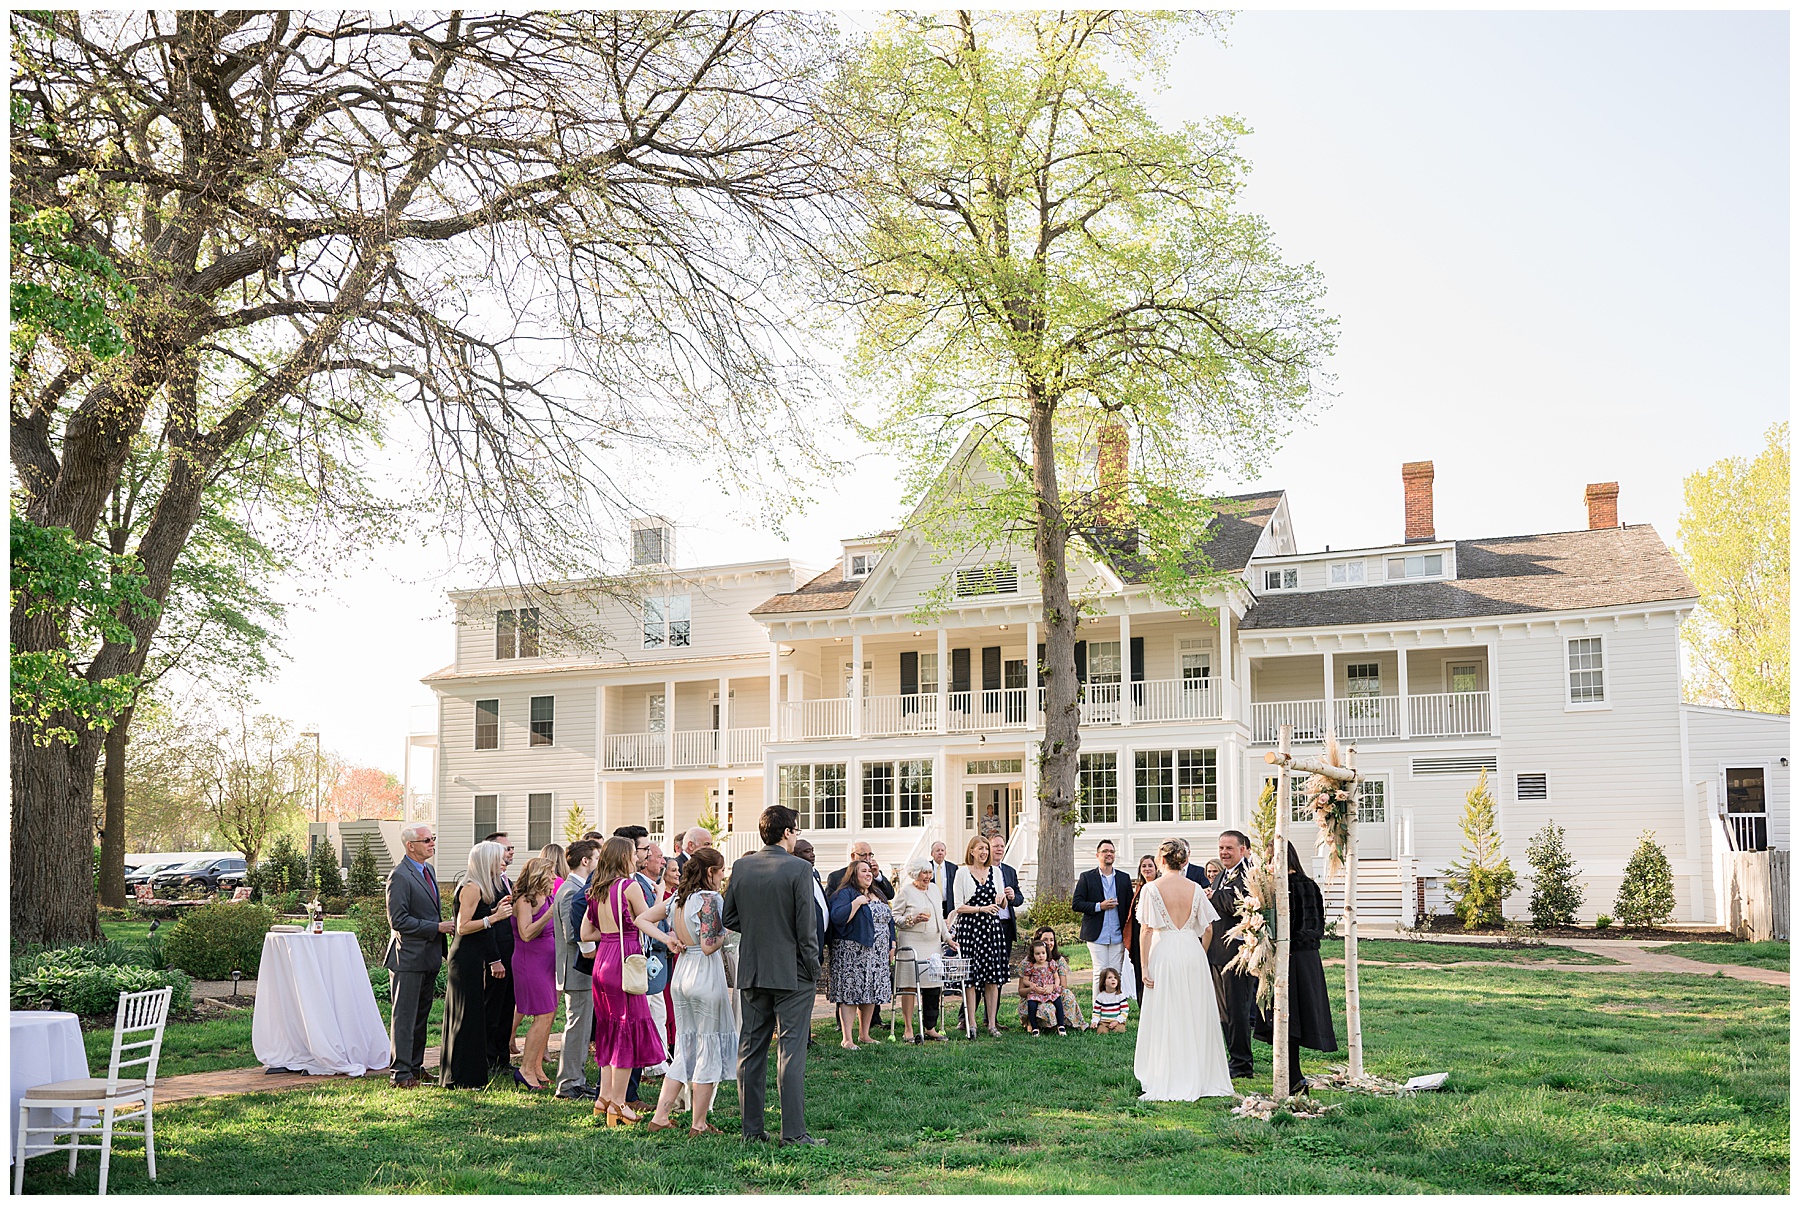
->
(826, 11), (1332, 893)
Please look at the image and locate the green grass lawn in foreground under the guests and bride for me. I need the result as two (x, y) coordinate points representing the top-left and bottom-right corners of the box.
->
(27, 965), (1789, 1196)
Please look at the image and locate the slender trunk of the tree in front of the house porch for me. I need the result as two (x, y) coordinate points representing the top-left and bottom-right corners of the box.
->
(1029, 402), (1082, 899)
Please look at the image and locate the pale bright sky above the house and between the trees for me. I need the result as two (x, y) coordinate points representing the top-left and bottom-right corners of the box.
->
(257, 11), (1789, 789)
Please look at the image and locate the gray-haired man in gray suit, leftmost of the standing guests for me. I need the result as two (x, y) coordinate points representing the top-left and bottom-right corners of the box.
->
(382, 825), (455, 1088)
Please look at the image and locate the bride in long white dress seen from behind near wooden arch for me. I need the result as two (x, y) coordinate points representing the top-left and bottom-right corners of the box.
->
(1132, 841), (1235, 1101)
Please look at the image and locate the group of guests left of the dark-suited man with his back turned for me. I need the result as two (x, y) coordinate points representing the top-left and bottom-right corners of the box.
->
(383, 825), (738, 1135)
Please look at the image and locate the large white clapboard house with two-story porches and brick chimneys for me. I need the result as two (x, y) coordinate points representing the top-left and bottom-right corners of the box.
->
(425, 446), (1787, 920)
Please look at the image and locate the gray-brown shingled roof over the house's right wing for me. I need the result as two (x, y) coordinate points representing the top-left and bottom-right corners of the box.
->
(1242, 524), (1697, 630)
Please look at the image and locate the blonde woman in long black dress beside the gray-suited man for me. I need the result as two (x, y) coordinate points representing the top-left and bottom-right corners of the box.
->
(437, 841), (513, 1088)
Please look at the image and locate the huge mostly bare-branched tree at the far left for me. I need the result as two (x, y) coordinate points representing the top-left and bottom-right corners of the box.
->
(9, 9), (841, 942)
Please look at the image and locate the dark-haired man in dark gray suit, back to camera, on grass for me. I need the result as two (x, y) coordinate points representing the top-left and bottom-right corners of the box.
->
(725, 805), (824, 1146)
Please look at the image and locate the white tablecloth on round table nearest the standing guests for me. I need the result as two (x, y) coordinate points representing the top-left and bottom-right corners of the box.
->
(250, 933), (389, 1075)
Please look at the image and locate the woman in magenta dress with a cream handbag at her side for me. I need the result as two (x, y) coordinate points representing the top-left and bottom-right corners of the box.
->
(581, 838), (679, 1126)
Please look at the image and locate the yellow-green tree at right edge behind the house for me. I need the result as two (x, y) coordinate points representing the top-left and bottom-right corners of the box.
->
(1676, 423), (1791, 715)
